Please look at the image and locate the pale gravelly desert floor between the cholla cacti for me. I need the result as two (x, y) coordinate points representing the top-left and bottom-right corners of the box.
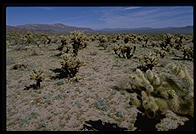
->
(6, 39), (193, 131)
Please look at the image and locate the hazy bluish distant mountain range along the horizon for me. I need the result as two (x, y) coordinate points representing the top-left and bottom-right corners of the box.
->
(6, 23), (193, 34)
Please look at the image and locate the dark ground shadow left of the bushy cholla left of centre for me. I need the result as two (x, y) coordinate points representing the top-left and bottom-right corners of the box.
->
(50, 68), (68, 80)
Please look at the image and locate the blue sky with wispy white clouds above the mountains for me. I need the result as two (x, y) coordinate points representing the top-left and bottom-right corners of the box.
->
(6, 6), (193, 29)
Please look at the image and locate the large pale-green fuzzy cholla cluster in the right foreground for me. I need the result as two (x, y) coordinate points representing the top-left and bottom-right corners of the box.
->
(130, 64), (194, 121)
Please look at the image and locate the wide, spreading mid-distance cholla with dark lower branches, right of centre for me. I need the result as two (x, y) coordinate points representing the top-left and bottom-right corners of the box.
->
(113, 43), (136, 59)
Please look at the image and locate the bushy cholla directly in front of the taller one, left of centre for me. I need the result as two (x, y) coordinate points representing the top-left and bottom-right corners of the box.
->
(61, 54), (84, 78)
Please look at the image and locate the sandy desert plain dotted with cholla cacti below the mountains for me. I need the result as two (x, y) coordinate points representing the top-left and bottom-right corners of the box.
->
(6, 31), (194, 131)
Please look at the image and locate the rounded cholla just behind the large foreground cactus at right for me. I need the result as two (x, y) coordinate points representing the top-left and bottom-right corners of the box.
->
(138, 52), (159, 72)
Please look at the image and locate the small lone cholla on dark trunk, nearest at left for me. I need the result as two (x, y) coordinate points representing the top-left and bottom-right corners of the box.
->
(30, 68), (45, 89)
